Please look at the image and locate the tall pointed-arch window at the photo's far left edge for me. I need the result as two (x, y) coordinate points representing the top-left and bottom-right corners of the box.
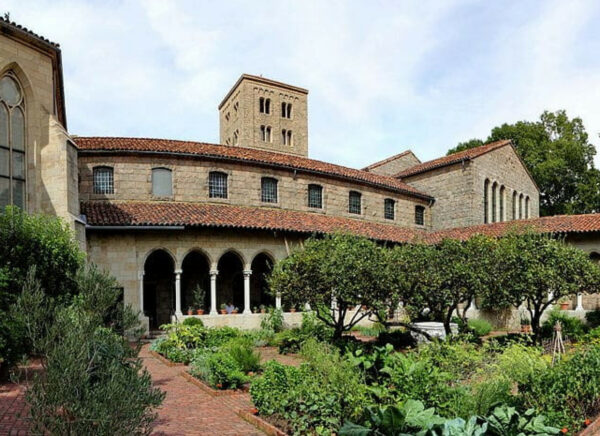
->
(0, 73), (25, 209)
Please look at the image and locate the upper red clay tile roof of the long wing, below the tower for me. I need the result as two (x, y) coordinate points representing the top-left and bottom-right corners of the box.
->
(73, 137), (432, 200)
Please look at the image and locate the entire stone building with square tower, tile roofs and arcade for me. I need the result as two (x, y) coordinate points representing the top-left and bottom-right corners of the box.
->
(0, 19), (600, 329)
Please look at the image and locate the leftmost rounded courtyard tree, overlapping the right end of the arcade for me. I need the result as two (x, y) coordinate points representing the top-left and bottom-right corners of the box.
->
(269, 234), (389, 338)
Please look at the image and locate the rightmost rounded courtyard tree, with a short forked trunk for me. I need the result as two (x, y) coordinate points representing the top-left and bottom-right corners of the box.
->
(483, 233), (600, 338)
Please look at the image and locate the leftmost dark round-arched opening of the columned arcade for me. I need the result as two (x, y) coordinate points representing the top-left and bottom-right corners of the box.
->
(143, 248), (175, 329)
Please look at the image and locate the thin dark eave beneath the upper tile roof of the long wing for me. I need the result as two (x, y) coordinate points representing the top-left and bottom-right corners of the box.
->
(75, 146), (435, 201)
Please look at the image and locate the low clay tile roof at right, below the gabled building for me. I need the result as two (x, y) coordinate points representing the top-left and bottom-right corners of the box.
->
(427, 213), (600, 243)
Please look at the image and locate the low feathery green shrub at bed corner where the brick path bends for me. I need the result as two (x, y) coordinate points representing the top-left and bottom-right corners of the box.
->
(190, 352), (248, 389)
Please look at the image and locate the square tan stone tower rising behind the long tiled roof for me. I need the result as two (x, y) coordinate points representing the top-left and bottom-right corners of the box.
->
(219, 74), (308, 156)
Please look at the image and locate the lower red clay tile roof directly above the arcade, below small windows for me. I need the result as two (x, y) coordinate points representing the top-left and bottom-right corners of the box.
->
(81, 201), (424, 242)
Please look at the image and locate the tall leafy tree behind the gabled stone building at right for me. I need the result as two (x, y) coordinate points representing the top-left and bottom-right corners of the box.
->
(448, 110), (600, 216)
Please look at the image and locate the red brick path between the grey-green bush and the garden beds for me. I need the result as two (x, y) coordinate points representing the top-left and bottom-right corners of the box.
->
(140, 345), (263, 435)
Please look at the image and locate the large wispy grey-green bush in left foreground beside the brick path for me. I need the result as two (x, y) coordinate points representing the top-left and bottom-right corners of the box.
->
(12, 268), (164, 435)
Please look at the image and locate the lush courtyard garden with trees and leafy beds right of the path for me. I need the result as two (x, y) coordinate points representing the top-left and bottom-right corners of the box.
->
(152, 234), (600, 435)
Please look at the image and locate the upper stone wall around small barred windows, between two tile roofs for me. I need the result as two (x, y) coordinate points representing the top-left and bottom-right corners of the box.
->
(79, 155), (431, 228)
